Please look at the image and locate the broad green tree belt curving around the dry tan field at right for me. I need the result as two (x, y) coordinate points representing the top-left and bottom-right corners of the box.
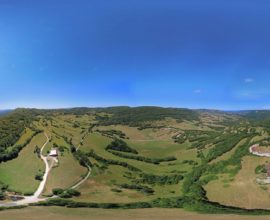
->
(179, 131), (268, 214)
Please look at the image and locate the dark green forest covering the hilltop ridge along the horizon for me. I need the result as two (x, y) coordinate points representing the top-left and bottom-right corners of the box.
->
(12, 106), (200, 126)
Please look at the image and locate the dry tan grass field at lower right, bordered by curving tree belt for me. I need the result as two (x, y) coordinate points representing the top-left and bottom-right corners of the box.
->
(206, 156), (270, 209)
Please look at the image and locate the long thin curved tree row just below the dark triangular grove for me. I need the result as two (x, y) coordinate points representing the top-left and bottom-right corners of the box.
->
(109, 151), (177, 164)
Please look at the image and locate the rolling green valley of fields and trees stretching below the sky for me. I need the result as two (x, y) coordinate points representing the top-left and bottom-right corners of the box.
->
(0, 107), (270, 214)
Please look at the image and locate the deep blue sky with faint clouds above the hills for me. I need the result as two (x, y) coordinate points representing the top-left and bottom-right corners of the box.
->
(0, 0), (270, 110)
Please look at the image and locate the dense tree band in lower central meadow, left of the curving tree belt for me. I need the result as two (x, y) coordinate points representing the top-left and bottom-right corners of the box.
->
(133, 173), (184, 185)
